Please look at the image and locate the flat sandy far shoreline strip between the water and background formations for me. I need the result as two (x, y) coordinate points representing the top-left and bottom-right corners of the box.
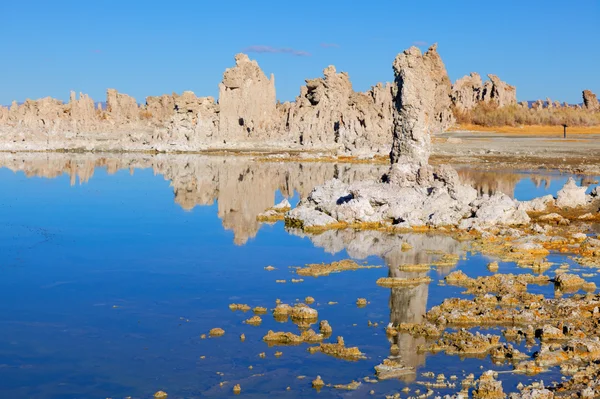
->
(0, 131), (600, 174)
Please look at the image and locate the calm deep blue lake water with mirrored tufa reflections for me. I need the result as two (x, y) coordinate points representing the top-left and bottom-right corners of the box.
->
(0, 154), (600, 398)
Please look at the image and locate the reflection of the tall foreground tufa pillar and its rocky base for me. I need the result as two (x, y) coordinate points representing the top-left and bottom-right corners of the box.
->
(288, 229), (464, 382)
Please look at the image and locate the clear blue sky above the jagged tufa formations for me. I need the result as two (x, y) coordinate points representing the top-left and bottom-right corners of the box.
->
(0, 0), (600, 104)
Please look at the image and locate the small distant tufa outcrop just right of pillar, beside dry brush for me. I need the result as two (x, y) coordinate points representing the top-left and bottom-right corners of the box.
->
(452, 72), (517, 111)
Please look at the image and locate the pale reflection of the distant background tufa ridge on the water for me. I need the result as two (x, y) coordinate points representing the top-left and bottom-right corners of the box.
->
(0, 153), (580, 245)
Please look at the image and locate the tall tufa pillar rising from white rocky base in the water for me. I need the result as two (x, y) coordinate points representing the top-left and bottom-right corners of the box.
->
(285, 47), (595, 234)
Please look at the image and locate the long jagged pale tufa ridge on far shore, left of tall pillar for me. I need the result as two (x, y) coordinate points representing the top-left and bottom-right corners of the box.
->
(0, 50), (393, 155)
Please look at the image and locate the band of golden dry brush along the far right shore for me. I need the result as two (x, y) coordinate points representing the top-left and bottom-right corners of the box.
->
(454, 104), (600, 127)
